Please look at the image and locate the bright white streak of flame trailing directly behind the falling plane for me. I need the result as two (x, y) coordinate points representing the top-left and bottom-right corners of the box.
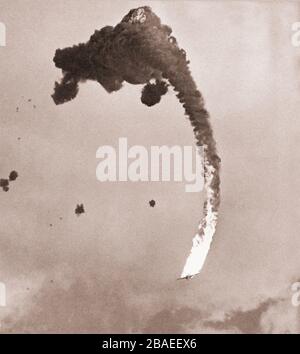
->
(181, 147), (218, 278)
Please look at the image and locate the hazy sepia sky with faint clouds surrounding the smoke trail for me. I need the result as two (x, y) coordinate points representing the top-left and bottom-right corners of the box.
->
(0, 0), (300, 333)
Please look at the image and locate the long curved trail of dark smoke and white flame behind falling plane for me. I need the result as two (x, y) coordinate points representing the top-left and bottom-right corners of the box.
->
(52, 7), (220, 278)
